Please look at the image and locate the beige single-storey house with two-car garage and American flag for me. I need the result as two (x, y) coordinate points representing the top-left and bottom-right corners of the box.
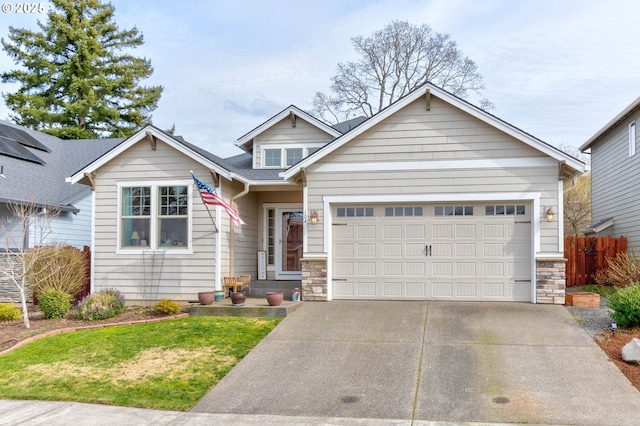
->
(68, 84), (584, 303)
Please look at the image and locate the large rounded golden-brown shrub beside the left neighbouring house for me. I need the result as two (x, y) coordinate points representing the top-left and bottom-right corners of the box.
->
(27, 246), (87, 296)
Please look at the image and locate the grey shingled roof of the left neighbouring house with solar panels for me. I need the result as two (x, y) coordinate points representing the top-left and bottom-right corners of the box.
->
(0, 120), (123, 213)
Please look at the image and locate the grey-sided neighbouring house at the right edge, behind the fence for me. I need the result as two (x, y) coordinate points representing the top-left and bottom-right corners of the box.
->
(580, 97), (640, 252)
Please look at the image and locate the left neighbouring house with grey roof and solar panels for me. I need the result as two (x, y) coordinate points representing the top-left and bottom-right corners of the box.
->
(0, 120), (123, 301)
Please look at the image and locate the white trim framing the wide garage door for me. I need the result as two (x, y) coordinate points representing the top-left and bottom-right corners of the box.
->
(322, 192), (542, 303)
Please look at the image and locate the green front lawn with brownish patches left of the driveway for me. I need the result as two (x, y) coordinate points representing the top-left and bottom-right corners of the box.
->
(0, 317), (280, 411)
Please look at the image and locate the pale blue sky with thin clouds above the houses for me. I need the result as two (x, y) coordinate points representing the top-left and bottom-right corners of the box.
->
(0, 0), (640, 157)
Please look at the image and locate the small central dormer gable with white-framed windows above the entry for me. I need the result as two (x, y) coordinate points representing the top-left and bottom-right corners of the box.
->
(236, 105), (342, 169)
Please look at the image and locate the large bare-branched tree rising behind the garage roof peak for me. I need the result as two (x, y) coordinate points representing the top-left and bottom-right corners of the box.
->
(313, 21), (493, 122)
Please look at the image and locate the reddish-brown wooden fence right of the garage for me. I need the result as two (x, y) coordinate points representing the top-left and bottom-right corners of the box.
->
(564, 237), (627, 287)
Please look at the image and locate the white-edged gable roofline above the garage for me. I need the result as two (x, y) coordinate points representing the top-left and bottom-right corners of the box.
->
(282, 83), (584, 179)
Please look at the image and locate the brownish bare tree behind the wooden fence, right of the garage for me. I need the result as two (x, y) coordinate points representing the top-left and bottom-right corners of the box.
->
(564, 173), (591, 237)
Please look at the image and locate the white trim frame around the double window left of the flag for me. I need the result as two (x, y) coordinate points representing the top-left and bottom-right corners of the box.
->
(116, 179), (194, 255)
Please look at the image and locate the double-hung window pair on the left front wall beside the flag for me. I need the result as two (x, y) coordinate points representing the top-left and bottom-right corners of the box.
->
(118, 182), (191, 252)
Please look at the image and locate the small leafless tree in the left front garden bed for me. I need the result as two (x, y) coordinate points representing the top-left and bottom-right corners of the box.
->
(0, 202), (60, 328)
